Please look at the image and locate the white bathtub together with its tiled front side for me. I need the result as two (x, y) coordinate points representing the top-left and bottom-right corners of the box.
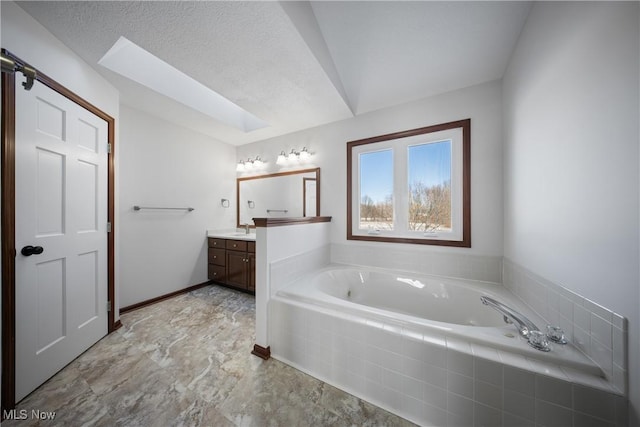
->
(268, 265), (626, 426)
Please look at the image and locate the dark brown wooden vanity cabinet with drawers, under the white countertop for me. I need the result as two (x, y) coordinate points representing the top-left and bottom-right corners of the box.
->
(208, 237), (256, 293)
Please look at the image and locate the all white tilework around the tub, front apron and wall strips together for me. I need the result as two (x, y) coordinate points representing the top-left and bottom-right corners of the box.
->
(268, 244), (627, 426)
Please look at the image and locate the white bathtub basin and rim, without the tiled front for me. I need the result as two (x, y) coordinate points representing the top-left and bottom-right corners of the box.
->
(277, 266), (603, 376)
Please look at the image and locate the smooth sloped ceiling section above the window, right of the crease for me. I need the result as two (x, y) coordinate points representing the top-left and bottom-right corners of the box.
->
(312, 2), (530, 114)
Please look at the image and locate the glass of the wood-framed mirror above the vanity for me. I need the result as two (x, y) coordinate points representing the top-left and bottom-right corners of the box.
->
(236, 168), (320, 228)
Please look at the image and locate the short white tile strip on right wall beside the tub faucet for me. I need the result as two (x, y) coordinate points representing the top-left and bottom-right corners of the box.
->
(503, 258), (628, 394)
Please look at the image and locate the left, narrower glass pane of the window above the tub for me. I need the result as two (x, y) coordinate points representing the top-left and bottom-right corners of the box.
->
(359, 150), (393, 232)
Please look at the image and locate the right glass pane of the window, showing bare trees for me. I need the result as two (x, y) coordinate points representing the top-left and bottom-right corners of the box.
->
(407, 140), (452, 232)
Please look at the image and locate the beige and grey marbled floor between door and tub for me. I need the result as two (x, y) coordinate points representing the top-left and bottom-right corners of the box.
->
(2, 286), (413, 427)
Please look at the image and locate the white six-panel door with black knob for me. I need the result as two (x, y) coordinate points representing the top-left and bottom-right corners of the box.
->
(15, 79), (107, 401)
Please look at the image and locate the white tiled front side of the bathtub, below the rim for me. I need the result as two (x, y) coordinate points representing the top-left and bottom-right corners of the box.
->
(270, 296), (627, 426)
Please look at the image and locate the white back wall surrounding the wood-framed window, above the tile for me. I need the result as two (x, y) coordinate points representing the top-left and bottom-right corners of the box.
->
(237, 82), (502, 256)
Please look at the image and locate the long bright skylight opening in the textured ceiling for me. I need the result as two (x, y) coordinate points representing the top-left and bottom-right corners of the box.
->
(98, 37), (268, 133)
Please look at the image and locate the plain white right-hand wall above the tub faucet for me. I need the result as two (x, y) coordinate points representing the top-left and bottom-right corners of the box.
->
(503, 2), (640, 425)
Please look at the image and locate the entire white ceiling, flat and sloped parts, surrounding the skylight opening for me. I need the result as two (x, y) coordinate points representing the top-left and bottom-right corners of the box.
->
(18, 1), (530, 145)
